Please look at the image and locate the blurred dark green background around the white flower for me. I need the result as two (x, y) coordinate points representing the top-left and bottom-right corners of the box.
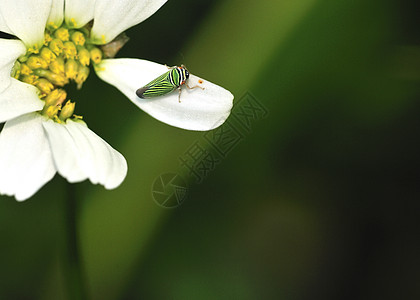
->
(0, 0), (420, 300)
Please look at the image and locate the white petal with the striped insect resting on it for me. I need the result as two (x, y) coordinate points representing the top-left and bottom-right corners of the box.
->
(96, 59), (233, 131)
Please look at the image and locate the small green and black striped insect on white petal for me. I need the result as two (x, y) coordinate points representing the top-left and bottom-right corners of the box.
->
(136, 65), (204, 102)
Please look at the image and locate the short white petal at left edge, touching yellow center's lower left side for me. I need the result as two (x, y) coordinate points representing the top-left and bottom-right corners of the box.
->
(0, 78), (44, 123)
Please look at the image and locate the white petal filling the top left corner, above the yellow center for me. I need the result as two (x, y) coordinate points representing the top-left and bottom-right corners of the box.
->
(0, 0), (52, 47)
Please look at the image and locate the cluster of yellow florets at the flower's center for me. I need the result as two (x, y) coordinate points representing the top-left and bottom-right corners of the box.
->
(15, 22), (110, 123)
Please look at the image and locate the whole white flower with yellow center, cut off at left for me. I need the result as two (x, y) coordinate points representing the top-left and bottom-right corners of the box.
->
(0, 0), (233, 200)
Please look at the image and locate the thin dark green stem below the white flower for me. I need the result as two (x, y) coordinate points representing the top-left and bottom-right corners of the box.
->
(65, 183), (87, 300)
